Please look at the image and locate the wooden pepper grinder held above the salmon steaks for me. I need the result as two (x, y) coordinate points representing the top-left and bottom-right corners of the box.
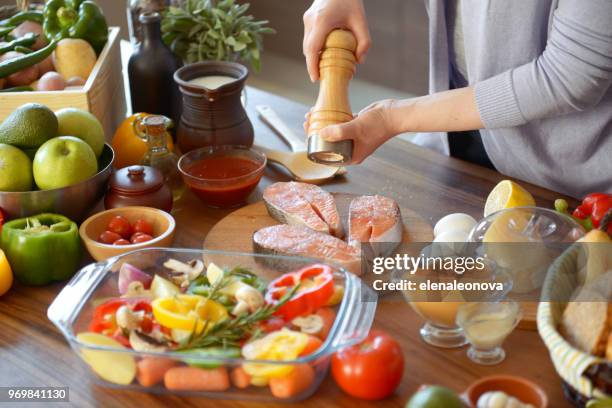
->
(308, 29), (357, 166)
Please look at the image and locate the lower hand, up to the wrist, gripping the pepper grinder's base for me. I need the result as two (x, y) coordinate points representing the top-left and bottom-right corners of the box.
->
(304, 99), (401, 164)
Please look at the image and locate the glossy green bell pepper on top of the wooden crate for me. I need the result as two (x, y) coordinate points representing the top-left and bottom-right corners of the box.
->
(43, 0), (108, 54)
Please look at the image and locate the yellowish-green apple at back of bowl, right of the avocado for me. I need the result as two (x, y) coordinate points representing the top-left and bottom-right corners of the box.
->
(55, 108), (104, 157)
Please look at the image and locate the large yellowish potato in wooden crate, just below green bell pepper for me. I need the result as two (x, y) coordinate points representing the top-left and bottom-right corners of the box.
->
(53, 38), (97, 79)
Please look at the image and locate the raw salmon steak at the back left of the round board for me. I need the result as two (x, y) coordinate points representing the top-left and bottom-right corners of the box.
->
(263, 181), (344, 238)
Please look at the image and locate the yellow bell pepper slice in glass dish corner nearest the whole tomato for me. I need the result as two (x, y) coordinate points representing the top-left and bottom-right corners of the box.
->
(242, 329), (308, 379)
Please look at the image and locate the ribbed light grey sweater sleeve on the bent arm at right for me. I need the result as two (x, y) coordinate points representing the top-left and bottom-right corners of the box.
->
(475, 0), (612, 128)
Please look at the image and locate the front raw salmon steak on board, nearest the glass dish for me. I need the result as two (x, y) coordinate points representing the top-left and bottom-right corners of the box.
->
(253, 224), (361, 275)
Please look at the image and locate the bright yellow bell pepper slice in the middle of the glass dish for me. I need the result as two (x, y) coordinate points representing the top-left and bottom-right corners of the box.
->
(151, 295), (228, 334)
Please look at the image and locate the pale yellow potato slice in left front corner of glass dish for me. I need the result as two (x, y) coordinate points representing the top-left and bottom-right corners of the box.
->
(77, 332), (136, 385)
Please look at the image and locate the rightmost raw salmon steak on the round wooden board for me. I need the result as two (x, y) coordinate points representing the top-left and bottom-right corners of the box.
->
(348, 195), (403, 255)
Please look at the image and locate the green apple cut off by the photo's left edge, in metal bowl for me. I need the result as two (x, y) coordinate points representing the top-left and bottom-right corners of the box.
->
(0, 143), (32, 191)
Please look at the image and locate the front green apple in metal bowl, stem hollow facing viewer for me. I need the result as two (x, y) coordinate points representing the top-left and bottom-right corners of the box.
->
(33, 136), (98, 190)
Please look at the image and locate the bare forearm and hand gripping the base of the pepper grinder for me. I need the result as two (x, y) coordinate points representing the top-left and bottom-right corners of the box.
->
(316, 87), (483, 163)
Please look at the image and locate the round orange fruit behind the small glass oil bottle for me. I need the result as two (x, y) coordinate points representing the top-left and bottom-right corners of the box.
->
(111, 113), (174, 169)
